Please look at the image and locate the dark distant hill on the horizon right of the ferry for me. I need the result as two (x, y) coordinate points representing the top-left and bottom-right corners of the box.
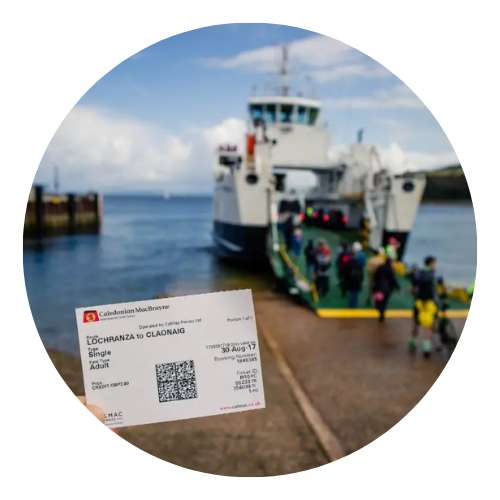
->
(423, 165), (471, 201)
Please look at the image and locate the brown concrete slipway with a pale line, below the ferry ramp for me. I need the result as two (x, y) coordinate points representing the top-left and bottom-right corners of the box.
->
(51, 292), (463, 476)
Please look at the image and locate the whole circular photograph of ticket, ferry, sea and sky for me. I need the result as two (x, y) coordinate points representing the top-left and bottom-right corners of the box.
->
(24, 24), (476, 476)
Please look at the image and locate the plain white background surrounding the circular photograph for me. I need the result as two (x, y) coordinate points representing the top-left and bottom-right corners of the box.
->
(0, 0), (500, 499)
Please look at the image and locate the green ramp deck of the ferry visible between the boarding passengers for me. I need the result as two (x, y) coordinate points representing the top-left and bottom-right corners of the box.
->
(271, 227), (469, 310)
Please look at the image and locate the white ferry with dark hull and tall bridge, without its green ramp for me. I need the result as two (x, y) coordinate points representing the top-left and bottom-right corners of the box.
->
(213, 47), (425, 264)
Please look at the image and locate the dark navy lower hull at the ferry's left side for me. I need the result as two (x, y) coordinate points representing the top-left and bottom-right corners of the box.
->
(213, 221), (268, 265)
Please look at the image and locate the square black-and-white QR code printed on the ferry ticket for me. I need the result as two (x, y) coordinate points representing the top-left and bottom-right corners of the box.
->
(156, 360), (198, 403)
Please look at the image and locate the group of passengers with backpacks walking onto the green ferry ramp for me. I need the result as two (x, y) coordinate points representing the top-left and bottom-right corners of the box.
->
(282, 209), (456, 356)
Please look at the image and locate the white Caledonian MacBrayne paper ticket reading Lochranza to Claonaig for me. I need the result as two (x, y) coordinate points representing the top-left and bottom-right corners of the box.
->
(76, 290), (265, 427)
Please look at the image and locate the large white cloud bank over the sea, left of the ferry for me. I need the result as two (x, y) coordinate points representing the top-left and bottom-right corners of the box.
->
(36, 106), (245, 191)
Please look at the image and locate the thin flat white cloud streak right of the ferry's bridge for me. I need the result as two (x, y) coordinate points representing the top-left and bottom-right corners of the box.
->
(325, 84), (427, 109)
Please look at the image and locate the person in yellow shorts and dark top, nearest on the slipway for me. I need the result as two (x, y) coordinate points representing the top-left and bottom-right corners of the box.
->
(408, 255), (438, 358)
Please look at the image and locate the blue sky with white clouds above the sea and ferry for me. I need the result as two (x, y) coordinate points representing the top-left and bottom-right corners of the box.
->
(35, 24), (458, 194)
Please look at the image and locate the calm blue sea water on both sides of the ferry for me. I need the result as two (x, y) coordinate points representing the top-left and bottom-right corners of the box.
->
(24, 196), (476, 352)
